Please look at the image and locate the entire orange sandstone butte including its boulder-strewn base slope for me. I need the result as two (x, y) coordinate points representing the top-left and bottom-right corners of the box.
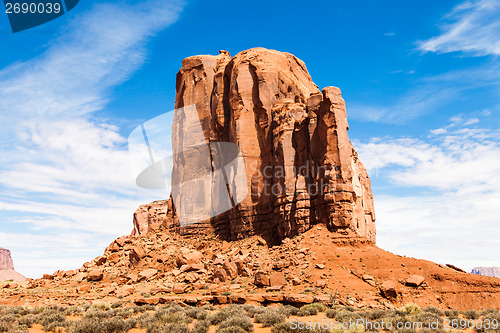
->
(0, 48), (500, 310)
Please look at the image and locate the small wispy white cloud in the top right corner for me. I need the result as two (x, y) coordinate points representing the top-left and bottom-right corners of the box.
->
(419, 0), (500, 56)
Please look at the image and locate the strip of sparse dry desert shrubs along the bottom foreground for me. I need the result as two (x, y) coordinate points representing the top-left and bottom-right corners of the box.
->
(0, 302), (500, 333)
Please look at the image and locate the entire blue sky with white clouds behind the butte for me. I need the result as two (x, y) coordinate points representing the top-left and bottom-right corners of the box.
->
(0, 0), (500, 277)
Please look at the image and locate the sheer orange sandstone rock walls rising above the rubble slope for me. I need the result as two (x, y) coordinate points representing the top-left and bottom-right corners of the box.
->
(133, 48), (375, 242)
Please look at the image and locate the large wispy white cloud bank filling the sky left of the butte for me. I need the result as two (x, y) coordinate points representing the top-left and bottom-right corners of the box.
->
(0, 0), (181, 276)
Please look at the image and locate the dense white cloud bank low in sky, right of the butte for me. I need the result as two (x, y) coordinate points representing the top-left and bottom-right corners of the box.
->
(356, 116), (500, 270)
